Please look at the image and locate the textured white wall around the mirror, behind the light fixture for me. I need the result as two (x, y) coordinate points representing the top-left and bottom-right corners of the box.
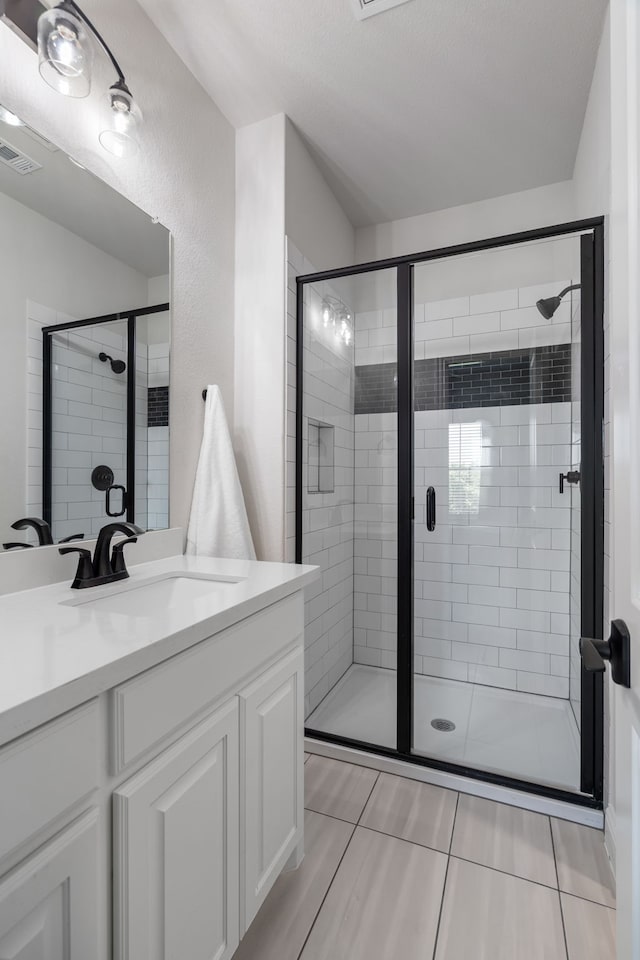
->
(0, 0), (234, 525)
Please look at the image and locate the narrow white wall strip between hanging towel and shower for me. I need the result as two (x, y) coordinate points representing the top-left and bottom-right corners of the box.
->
(234, 114), (286, 560)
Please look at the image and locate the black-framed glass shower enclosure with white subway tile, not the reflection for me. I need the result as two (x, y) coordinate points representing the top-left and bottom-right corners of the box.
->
(296, 219), (604, 807)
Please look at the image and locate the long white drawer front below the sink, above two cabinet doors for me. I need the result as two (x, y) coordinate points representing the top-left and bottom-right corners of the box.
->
(111, 592), (304, 773)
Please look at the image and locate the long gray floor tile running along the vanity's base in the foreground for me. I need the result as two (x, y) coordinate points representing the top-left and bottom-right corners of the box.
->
(234, 811), (354, 960)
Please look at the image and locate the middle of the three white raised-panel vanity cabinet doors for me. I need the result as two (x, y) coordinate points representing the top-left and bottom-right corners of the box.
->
(114, 698), (239, 960)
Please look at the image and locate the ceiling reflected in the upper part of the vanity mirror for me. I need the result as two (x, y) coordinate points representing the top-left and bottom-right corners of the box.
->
(0, 123), (169, 277)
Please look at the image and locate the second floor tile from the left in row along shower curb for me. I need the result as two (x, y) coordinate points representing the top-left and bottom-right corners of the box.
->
(360, 773), (458, 853)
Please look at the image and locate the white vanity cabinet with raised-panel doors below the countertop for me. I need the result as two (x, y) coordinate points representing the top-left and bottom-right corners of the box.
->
(0, 576), (304, 960)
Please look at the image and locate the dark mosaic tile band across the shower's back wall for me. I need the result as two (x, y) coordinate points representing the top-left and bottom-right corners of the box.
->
(355, 343), (571, 414)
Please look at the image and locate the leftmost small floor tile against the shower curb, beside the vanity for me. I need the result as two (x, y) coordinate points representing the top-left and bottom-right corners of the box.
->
(304, 755), (378, 823)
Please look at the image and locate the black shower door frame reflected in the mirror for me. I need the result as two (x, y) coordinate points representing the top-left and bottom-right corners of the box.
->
(42, 303), (170, 526)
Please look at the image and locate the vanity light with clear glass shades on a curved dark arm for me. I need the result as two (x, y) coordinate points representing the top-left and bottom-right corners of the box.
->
(38, 0), (142, 157)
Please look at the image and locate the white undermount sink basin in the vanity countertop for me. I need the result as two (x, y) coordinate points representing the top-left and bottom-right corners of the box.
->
(62, 572), (243, 617)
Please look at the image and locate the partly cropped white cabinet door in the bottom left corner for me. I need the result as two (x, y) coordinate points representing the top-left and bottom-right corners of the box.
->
(0, 810), (103, 960)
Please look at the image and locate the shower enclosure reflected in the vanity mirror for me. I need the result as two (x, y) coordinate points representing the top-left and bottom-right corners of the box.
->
(37, 303), (170, 541)
